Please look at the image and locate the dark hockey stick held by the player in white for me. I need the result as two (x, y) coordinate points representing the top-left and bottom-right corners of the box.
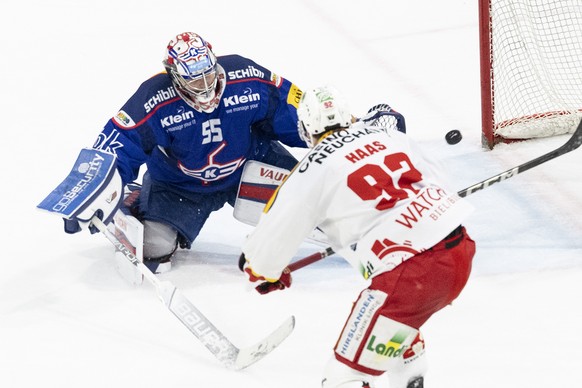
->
(288, 120), (582, 272)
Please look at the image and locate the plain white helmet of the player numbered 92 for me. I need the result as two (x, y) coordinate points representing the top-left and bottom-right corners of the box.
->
(297, 86), (352, 147)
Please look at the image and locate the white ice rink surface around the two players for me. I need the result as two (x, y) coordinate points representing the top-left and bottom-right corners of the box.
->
(0, 0), (582, 388)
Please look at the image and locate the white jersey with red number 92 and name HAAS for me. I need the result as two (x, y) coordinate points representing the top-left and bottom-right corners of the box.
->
(242, 122), (473, 279)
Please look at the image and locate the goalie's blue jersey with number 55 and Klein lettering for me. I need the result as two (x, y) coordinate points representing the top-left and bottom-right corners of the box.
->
(93, 55), (306, 192)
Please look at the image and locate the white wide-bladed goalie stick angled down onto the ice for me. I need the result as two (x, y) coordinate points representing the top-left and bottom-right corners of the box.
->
(91, 216), (295, 370)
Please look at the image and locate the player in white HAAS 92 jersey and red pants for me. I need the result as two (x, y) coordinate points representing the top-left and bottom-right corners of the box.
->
(239, 87), (475, 388)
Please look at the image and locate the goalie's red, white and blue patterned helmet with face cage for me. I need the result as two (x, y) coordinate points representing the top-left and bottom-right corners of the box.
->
(163, 32), (224, 113)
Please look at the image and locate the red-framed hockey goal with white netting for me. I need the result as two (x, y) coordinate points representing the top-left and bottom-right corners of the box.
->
(479, 0), (582, 148)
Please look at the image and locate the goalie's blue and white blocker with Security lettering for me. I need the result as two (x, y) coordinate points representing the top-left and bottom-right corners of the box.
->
(37, 148), (123, 234)
